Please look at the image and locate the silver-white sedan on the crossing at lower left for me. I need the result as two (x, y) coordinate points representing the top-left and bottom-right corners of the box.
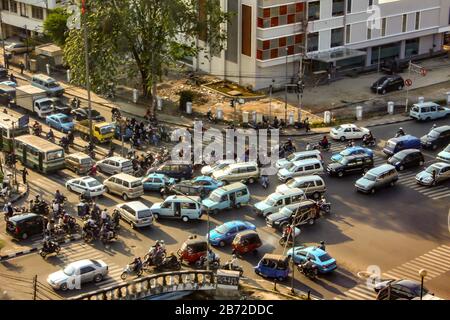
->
(47, 259), (109, 291)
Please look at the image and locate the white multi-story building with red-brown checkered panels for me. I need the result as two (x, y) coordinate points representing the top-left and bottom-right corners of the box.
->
(192, 0), (450, 89)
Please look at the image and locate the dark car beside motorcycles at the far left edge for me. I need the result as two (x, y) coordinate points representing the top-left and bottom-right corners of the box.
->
(6, 213), (47, 240)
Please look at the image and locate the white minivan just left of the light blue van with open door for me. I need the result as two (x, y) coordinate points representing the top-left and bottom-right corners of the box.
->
(116, 201), (153, 229)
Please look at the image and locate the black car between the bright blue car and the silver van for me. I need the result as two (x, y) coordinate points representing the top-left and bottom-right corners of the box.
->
(327, 153), (373, 177)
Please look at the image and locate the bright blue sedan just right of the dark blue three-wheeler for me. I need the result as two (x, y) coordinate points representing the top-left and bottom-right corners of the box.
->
(287, 246), (337, 273)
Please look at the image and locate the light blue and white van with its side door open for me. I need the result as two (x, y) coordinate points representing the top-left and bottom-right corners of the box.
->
(150, 195), (203, 222)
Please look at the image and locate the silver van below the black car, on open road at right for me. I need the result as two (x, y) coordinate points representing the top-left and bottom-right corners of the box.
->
(355, 164), (398, 194)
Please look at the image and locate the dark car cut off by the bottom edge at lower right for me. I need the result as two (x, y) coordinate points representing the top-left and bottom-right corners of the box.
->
(374, 279), (432, 300)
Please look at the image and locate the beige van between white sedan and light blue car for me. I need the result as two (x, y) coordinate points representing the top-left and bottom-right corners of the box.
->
(103, 173), (144, 201)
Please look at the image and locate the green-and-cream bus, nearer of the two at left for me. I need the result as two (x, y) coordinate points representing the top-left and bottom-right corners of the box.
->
(14, 134), (65, 173)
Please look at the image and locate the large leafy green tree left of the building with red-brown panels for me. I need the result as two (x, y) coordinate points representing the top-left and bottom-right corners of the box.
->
(65, 0), (229, 110)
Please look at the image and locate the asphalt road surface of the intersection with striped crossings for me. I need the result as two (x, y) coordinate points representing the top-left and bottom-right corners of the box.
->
(0, 84), (450, 299)
